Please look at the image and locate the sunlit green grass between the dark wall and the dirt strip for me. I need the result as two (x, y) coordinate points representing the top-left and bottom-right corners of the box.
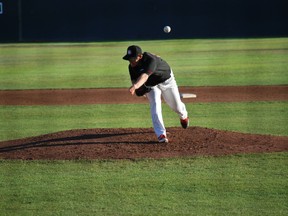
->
(0, 38), (288, 89)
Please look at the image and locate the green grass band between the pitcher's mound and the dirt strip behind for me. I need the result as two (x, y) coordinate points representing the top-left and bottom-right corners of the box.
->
(0, 102), (288, 140)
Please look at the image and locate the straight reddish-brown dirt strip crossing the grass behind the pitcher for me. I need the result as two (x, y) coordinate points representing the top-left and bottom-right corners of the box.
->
(0, 86), (288, 105)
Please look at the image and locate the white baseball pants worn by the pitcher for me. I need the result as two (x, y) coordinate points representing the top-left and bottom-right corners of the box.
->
(146, 70), (188, 137)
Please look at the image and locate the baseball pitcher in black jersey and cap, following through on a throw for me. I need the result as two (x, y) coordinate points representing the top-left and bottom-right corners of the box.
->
(123, 45), (189, 143)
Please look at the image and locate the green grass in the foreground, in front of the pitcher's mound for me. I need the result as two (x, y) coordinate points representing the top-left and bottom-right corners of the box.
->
(0, 153), (288, 216)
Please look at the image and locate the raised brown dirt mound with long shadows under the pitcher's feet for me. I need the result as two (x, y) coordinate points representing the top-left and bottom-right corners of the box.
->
(0, 127), (288, 160)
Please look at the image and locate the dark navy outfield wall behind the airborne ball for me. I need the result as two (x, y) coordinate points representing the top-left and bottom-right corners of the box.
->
(0, 0), (288, 42)
